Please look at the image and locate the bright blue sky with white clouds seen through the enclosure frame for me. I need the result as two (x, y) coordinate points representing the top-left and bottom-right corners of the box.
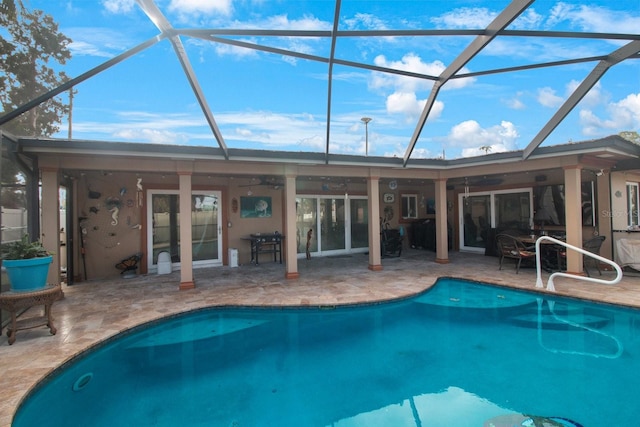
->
(27, 0), (640, 158)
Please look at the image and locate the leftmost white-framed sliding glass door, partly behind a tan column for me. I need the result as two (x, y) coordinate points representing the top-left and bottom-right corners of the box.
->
(147, 190), (222, 270)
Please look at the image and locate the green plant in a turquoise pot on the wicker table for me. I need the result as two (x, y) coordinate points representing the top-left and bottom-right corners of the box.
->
(2, 234), (53, 292)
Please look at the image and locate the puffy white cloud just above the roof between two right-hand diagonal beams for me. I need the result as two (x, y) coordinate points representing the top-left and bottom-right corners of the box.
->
(447, 120), (520, 157)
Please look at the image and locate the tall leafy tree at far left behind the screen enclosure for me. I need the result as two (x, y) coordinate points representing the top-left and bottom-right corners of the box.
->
(0, 0), (71, 208)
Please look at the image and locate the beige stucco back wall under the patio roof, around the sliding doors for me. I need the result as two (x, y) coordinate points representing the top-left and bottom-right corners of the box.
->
(69, 171), (420, 281)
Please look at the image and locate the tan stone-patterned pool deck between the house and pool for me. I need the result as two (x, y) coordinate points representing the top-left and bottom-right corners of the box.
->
(0, 250), (640, 427)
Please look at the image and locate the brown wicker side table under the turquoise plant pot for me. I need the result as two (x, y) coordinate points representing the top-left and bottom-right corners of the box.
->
(0, 285), (62, 345)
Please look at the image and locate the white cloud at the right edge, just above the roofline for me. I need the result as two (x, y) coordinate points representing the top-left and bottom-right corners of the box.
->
(580, 93), (640, 136)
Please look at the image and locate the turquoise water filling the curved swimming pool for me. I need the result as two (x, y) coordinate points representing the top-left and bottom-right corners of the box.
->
(13, 279), (640, 427)
